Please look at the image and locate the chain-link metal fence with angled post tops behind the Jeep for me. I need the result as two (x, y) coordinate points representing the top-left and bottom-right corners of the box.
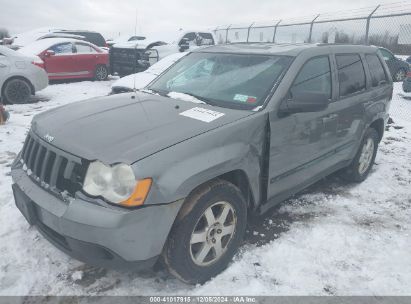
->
(214, 1), (411, 55)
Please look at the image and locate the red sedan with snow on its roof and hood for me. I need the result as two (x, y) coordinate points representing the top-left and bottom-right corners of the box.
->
(18, 38), (109, 80)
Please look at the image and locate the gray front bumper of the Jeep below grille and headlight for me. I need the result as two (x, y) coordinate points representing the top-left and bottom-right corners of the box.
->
(12, 168), (182, 269)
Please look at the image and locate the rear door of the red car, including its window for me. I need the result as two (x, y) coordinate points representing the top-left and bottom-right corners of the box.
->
(73, 42), (99, 77)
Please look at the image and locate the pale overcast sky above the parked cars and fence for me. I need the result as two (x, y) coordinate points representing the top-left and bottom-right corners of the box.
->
(0, 0), (398, 38)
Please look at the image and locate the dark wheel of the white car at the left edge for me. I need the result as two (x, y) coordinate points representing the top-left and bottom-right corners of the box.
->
(3, 78), (31, 104)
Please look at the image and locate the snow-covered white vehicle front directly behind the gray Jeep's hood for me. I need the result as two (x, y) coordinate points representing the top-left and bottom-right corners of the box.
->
(111, 52), (189, 94)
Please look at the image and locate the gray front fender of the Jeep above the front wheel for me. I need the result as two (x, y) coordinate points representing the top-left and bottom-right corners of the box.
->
(133, 113), (266, 205)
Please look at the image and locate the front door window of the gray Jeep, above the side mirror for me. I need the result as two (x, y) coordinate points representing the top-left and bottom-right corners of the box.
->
(290, 56), (331, 98)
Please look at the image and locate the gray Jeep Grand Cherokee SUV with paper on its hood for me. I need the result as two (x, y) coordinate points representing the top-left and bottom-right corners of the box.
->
(12, 44), (393, 283)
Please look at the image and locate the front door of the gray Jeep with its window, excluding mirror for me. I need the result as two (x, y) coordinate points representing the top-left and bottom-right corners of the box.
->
(267, 54), (338, 200)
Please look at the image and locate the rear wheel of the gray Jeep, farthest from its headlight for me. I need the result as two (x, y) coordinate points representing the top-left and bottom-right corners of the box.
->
(342, 128), (379, 183)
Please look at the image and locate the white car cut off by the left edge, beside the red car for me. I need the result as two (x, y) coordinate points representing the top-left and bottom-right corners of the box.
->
(0, 46), (49, 104)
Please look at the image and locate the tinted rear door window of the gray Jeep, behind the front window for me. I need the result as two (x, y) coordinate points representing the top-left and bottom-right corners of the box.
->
(335, 54), (365, 97)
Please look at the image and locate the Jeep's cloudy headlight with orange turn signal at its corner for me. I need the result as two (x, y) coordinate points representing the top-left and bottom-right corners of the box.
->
(83, 161), (152, 207)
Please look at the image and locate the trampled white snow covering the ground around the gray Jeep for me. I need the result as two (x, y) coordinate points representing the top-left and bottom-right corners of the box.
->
(0, 81), (411, 295)
